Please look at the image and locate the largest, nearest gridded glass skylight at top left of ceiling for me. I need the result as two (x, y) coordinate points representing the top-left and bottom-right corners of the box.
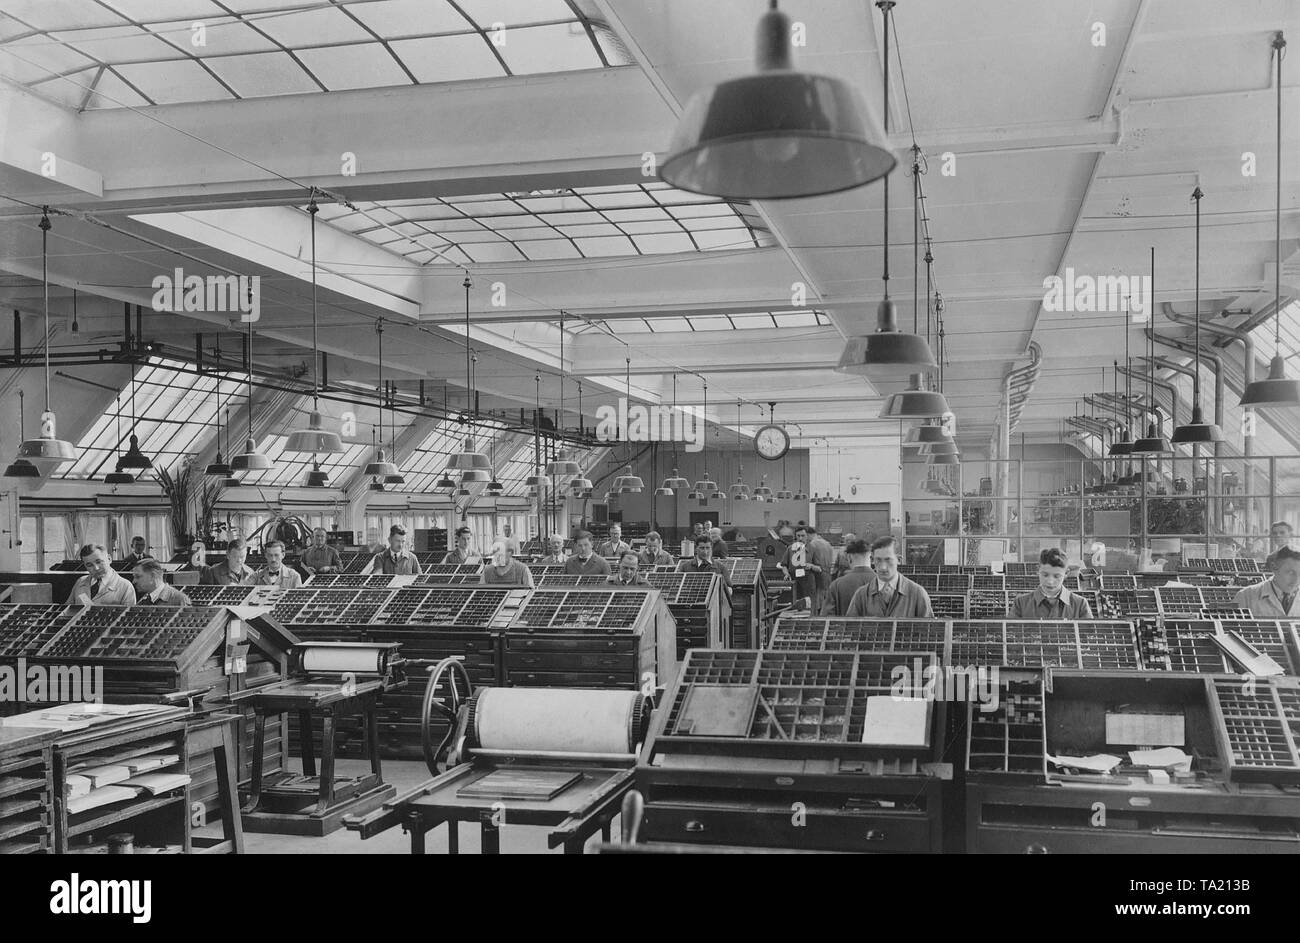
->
(0, 0), (625, 108)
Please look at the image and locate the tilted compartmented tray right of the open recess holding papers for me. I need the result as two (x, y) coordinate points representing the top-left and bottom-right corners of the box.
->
(1212, 678), (1300, 784)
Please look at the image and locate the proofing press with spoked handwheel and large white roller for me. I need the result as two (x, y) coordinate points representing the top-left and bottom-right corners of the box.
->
(343, 658), (650, 855)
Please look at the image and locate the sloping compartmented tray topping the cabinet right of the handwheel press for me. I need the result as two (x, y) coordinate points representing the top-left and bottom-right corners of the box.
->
(663, 649), (936, 752)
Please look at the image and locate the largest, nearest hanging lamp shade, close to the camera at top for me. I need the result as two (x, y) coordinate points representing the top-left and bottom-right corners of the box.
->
(660, 9), (897, 200)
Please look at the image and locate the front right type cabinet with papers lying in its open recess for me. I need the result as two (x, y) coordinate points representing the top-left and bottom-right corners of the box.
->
(966, 670), (1300, 855)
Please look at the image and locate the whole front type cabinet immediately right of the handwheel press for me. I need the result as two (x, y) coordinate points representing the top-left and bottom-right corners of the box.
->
(636, 649), (944, 852)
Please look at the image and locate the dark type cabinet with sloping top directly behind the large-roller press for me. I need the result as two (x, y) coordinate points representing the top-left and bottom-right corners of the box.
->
(503, 585), (677, 689)
